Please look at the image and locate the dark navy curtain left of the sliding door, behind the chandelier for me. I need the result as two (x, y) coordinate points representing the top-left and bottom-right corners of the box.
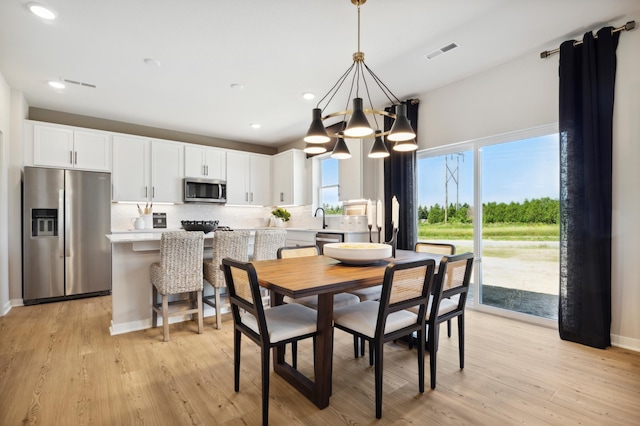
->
(384, 99), (419, 250)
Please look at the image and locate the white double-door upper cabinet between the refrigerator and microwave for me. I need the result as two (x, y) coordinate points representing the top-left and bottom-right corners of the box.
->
(112, 135), (184, 203)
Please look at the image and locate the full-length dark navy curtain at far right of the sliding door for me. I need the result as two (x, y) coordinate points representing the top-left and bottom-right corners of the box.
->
(558, 27), (619, 348)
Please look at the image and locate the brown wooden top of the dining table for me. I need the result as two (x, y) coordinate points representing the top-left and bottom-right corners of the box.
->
(253, 250), (442, 298)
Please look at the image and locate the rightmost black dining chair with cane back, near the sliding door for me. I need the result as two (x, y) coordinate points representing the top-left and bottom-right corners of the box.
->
(409, 253), (473, 389)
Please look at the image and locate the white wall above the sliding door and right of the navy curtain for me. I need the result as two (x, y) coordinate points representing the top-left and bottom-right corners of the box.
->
(418, 11), (640, 350)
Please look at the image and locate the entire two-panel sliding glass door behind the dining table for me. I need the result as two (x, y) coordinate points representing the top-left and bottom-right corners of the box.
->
(417, 126), (560, 319)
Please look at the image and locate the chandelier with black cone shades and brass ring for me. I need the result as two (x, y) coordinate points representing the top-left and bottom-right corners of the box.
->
(304, 0), (418, 159)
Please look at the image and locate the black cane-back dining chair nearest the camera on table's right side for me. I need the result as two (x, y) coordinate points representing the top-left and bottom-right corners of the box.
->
(333, 259), (435, 419)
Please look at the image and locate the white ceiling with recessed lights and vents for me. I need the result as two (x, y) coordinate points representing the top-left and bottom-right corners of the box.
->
(0, 0), (640, 147)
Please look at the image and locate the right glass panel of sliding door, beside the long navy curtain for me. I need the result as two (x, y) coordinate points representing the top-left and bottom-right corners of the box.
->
(479, 134), (560, 319)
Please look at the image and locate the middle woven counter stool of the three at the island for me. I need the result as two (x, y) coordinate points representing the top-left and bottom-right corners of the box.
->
(202, 231), (250, 329)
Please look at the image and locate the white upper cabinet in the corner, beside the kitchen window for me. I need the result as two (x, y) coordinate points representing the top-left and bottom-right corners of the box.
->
(272, 149), (306, 206)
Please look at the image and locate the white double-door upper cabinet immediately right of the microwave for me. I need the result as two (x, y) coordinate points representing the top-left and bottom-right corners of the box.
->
(227, 151), (271, 206)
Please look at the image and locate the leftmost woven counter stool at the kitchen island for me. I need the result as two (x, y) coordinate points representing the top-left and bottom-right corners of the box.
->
(150, 231), (204, 342)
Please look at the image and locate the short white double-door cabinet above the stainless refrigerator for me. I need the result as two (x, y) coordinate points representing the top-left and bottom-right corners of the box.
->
(33, 124), (111, 171)
